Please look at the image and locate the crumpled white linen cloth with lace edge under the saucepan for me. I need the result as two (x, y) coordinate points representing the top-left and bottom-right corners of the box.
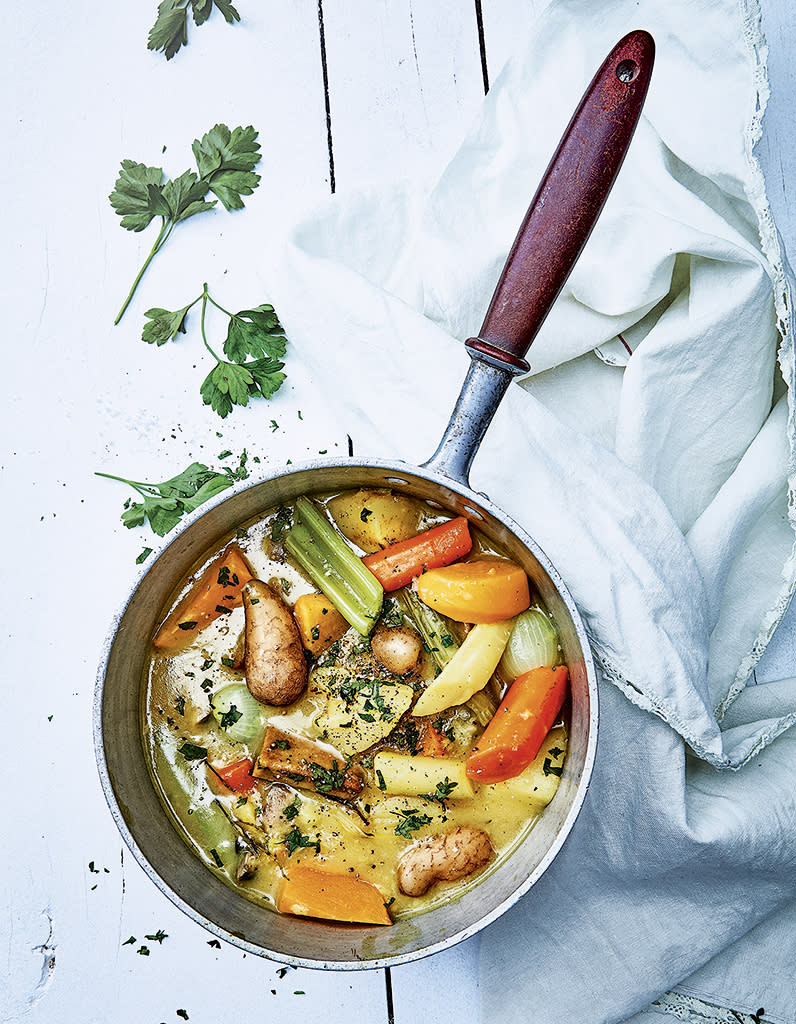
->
(265, 0), (796, 1024)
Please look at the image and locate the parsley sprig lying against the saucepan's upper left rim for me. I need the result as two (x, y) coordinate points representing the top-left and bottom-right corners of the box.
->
(95, 449), (249, 537)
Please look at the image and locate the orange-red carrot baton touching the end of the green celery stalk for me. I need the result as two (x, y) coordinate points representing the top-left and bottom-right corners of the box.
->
(363, 516), (472, 593)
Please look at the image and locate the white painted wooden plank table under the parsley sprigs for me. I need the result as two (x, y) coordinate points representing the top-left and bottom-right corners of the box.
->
(0, 0), (796, 1024)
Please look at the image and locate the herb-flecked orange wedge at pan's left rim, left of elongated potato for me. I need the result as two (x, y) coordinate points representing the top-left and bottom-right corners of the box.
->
(155, 544), (254, 650)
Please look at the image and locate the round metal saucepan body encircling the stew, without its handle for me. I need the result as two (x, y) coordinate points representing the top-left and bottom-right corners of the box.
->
(94, 450), (597, 969)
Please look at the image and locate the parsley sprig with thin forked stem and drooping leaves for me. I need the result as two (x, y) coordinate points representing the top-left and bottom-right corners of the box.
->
(141, 285), (287, 419)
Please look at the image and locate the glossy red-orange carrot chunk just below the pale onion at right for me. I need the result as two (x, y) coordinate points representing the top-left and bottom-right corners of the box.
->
(465, 665), (570, 782)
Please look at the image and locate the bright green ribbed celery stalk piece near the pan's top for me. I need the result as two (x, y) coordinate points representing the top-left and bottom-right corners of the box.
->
(285, 497), (384, 636)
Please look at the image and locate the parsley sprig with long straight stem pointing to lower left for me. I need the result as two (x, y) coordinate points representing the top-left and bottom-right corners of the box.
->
(109, 124), (260, 324)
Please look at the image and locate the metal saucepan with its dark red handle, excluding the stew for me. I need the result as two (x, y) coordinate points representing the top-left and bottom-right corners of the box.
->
(94, 31), (655, 970)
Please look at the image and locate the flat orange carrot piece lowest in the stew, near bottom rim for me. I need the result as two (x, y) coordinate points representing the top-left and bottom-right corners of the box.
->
(277, 864), (392, 925)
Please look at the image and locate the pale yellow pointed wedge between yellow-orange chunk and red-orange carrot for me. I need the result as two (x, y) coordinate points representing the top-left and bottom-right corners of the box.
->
(412, 618), (513, 715)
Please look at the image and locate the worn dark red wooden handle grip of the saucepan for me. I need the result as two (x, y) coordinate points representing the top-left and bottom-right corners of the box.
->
(465, 31), (655, 372)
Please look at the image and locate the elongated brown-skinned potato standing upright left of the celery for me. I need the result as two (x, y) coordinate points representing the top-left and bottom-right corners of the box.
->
(243, 580), (307, 706)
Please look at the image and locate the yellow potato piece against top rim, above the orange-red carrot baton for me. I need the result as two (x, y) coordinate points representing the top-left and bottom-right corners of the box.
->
(328, 489), (420, 553)
